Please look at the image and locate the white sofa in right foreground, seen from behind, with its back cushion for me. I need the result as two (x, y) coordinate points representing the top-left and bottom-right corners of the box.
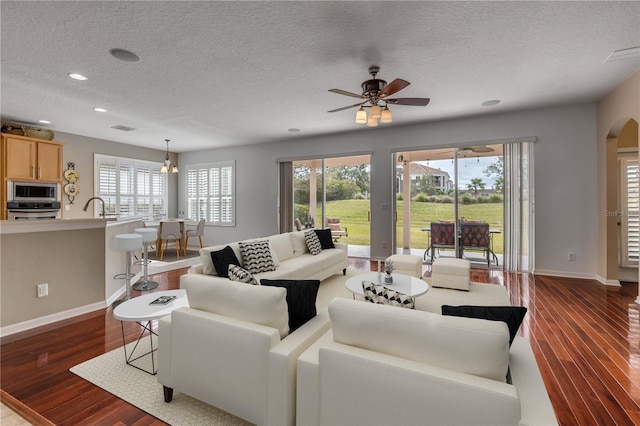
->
(297, 298), (557, 425)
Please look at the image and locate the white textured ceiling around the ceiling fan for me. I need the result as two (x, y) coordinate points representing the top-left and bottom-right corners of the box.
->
(0, 1), (640, 152)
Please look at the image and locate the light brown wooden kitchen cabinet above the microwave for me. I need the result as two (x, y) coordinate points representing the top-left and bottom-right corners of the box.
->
(2, 134), (64, 182)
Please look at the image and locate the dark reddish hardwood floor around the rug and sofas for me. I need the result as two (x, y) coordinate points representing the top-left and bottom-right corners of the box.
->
(0, 259), (640, 425)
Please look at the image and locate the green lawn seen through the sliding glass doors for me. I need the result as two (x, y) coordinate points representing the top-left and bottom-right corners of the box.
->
(316, 200), (504, 254)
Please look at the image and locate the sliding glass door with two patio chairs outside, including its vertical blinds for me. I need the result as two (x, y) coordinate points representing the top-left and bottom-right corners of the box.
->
(395, 142), (533, 271)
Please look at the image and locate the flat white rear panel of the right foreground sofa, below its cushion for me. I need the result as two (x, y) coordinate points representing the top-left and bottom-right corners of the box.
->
(304, 342), (520, 425)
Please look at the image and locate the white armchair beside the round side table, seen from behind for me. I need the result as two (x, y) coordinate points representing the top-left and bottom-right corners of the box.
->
(158, 274), (330, 425)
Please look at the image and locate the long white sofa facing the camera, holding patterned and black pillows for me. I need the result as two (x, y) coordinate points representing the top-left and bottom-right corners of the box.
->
(182, 231), (347, 282)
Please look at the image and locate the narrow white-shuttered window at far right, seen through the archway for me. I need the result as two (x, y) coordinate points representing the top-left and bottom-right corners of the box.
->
(619, 153), (640, 267)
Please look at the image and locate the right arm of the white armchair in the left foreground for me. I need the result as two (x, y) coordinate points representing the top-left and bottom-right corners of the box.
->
(269, 311), (331, 425)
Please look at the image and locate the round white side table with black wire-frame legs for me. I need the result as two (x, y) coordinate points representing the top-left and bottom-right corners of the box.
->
(113, 290), (189, 375)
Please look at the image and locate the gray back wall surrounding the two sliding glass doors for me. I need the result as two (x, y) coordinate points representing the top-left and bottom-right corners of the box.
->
(178, 103), (598, 278)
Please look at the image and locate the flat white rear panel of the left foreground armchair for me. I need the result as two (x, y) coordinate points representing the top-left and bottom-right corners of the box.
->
(158, 308), (280, 424)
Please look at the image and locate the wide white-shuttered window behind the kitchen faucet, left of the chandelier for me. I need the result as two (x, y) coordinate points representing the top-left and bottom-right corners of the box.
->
(94, 154), (167, 219)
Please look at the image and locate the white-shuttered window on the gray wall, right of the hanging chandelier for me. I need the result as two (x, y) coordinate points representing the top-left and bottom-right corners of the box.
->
(186, 161), (235, 226)
